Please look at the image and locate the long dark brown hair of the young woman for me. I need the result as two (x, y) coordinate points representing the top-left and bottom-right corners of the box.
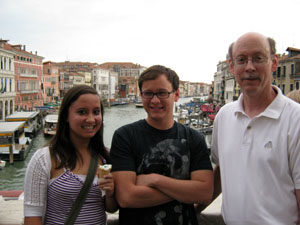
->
(49, 85), (108, 170)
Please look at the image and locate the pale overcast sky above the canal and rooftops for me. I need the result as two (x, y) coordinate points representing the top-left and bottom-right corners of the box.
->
(0, 0), (300, 83)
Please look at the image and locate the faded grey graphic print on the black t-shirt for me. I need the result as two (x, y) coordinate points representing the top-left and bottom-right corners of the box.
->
(137, 139), (190, 225)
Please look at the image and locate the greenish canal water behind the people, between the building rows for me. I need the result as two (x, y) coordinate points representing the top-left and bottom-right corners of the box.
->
(0, 98), (191, 190)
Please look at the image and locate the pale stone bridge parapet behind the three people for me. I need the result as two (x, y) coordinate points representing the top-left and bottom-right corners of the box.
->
(0, 191), (225, 225)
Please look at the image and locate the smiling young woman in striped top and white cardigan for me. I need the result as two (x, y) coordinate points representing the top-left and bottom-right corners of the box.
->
(24, 85), (118, 225)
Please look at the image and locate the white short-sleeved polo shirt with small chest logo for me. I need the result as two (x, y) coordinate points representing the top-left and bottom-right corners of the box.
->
(212, 87), (300, 225)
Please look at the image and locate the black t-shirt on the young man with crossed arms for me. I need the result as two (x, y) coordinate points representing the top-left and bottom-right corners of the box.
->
(110, 120), (212, 225)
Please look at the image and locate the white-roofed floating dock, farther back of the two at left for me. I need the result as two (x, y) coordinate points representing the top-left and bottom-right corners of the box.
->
(6, 111), (42, 138)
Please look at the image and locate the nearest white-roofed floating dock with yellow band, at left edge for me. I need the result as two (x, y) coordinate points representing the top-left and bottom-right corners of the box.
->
(0, 121), (31, 162)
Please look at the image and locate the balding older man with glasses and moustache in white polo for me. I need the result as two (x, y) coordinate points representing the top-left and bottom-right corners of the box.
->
(212, 33), (300, 225)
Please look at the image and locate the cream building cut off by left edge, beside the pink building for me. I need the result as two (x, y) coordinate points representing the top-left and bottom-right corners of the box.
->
(0, 40), (16, 121)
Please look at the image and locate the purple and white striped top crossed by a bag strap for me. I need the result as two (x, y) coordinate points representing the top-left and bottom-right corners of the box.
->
(44, 170), (106, 225)
